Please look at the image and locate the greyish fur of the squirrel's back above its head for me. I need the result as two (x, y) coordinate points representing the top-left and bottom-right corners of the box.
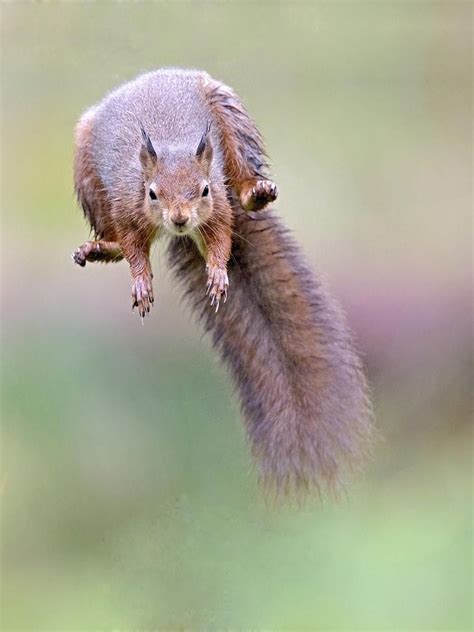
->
(82, 68), (222, 197)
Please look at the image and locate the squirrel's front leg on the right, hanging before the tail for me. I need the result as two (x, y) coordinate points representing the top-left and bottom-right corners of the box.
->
(198, 193), (232, 312)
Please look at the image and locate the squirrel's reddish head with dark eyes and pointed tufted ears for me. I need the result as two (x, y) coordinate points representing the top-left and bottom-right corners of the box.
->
(140, 124), (213, 235)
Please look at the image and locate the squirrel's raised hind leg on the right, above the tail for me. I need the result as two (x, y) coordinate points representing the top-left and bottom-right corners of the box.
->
(205, 80), (278, 211)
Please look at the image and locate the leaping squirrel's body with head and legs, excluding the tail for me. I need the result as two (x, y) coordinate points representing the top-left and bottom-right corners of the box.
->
(73, 69), (278, 318)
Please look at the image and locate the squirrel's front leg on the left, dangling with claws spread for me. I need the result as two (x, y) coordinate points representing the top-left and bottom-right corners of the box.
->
(120, 231), (156, 318)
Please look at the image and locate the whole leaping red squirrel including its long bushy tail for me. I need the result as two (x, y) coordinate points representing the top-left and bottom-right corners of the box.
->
(73, 69), (373, 494)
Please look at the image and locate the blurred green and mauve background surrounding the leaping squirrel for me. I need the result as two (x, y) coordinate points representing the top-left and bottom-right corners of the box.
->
(0, 2), (472, 631)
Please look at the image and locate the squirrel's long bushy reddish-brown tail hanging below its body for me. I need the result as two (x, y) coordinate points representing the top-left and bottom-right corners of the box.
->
(169, 208), (372, 493)
